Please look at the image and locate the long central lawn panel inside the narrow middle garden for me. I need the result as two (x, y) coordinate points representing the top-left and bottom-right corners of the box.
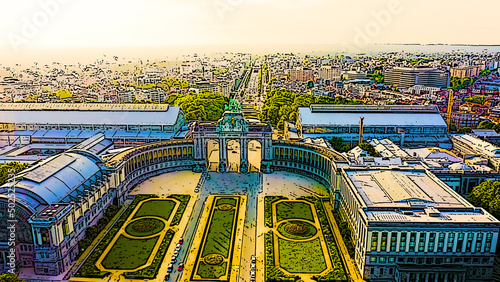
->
(201, 209), (236, 258)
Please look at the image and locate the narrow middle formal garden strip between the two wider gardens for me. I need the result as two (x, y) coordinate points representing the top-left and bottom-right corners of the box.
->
(191, 196), (241, 281)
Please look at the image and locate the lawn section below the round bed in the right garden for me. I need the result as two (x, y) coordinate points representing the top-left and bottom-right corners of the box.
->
(278, 238), (326, 273)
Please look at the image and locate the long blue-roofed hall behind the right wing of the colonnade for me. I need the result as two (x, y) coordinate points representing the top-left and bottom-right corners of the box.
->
(296, 104), (449, 147)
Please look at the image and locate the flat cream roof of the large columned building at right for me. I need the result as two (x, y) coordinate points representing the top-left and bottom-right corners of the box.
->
(344, 167), (500, 224)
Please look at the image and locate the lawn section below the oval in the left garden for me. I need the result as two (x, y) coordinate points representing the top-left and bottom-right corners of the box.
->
(102, 235), (159, 269)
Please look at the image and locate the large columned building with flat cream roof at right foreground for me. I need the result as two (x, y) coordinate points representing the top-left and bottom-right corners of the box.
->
(336, 166), (500, 282)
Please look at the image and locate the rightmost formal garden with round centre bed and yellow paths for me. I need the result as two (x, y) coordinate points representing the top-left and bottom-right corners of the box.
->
(264, 196), (348, 282)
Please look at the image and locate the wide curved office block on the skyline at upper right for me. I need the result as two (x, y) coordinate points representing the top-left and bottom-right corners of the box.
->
(385, 67), (450, 88)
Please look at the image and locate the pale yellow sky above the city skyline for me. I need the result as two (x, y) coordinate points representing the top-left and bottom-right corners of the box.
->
(0, 0), (500, 51)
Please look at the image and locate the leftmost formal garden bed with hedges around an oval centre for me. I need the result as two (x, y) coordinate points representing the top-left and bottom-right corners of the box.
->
(75, 195), (190, 279)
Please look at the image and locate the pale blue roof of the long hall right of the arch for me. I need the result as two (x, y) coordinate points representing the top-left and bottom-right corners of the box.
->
(299, 108), (446, 127)
